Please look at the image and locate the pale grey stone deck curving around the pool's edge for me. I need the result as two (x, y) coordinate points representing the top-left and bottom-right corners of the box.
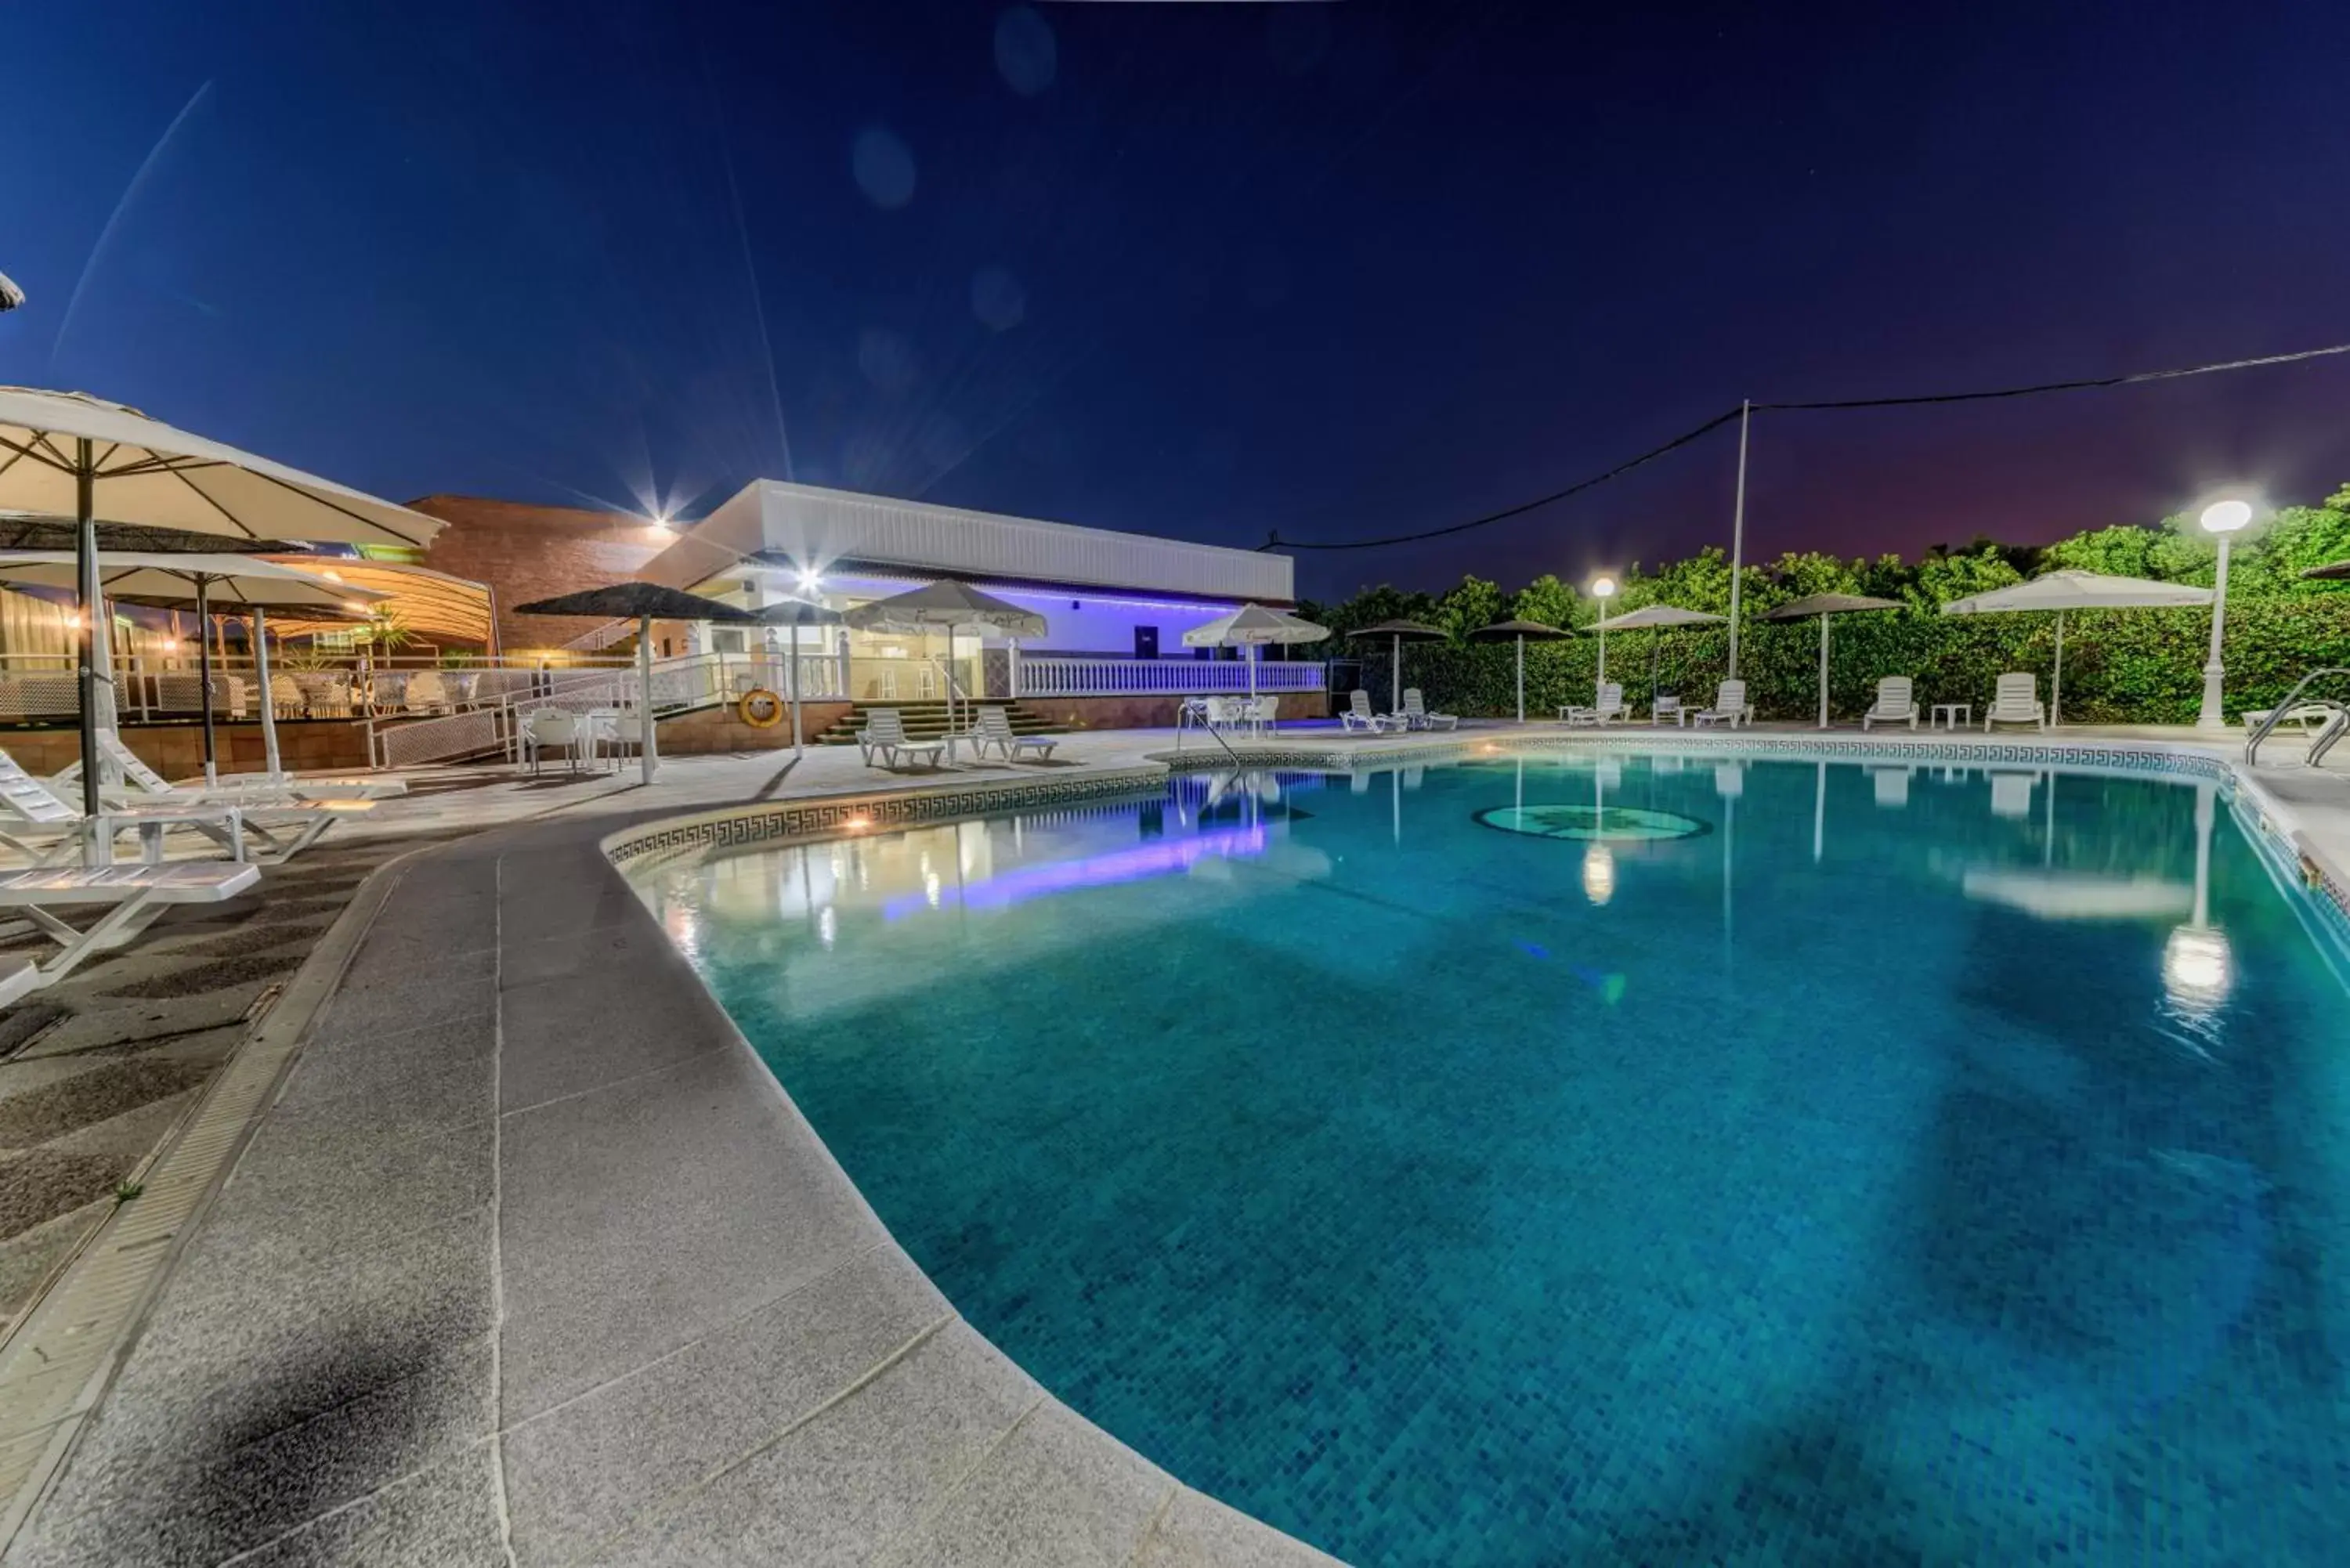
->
(0, 724), (2350, 1568)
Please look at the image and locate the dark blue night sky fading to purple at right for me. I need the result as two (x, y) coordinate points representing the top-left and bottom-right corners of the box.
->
(0, 0), (2350, 592)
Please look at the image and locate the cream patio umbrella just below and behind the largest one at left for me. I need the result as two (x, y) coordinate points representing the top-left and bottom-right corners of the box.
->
(0, 550), (390, 782)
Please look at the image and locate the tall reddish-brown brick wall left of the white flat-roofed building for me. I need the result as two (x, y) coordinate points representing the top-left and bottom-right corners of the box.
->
(409, 496), (670, 653)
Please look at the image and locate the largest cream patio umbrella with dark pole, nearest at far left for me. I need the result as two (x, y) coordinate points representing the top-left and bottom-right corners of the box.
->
(0, 385), (442, 827)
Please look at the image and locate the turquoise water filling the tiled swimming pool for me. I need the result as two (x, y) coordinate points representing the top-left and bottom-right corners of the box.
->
(644, 754), (2350, 1566)
